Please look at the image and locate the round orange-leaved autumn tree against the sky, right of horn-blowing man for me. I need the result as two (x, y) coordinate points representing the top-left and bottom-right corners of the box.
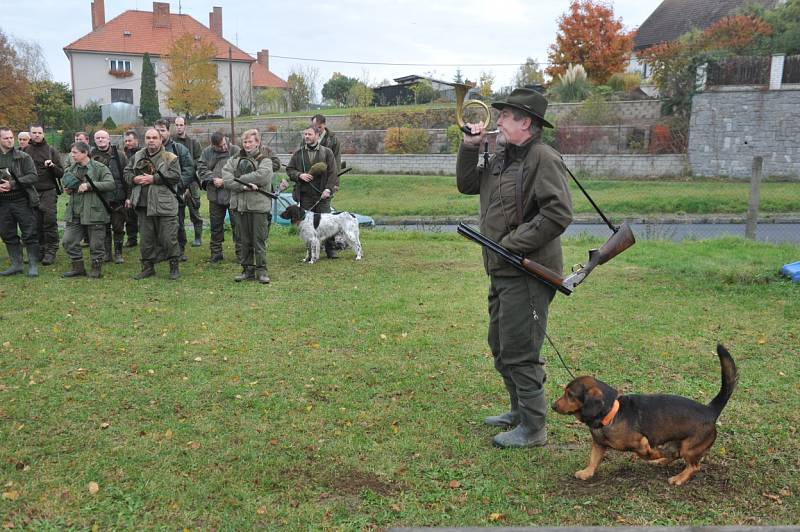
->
(546, 0), (634, 85)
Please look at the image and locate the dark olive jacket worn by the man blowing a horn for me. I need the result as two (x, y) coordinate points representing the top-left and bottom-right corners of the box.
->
(456, 140), (572, 276)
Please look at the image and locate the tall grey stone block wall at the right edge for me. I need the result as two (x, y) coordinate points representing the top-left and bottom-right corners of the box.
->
(688, 88), (800, 178)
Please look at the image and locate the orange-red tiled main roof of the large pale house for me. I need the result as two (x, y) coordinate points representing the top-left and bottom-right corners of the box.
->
(64, 10), (255, 62)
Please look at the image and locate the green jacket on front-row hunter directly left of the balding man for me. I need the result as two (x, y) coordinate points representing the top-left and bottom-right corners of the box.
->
(61, 159), (117, 225)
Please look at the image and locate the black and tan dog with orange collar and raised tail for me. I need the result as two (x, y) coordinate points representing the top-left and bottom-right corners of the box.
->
(553, 345), (736, 486)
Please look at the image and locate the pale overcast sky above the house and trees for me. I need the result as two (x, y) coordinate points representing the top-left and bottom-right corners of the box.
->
(0, 0), (661, 97)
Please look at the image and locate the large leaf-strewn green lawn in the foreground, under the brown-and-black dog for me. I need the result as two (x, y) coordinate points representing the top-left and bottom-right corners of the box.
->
(0, 228), (800, 530)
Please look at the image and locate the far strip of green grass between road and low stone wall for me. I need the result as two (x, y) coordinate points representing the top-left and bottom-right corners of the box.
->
(335, 174), (800, 218)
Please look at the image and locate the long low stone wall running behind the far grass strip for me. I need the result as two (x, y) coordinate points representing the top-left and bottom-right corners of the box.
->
(280, 154), (689, 179)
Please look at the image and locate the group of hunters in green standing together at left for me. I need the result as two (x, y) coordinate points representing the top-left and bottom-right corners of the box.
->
(0, 115), (341, 284)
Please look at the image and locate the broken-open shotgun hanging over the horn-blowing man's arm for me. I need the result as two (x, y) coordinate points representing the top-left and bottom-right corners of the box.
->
(457, 223), (636, 296)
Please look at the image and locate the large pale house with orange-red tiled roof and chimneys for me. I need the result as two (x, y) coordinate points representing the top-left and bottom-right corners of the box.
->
(64, 0), (286, 117)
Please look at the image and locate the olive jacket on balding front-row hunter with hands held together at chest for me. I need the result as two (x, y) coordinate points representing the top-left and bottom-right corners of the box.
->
(125, 148), (181, 216)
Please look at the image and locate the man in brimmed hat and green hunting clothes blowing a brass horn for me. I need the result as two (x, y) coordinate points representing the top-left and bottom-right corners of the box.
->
(456, 88), (572, 447)
